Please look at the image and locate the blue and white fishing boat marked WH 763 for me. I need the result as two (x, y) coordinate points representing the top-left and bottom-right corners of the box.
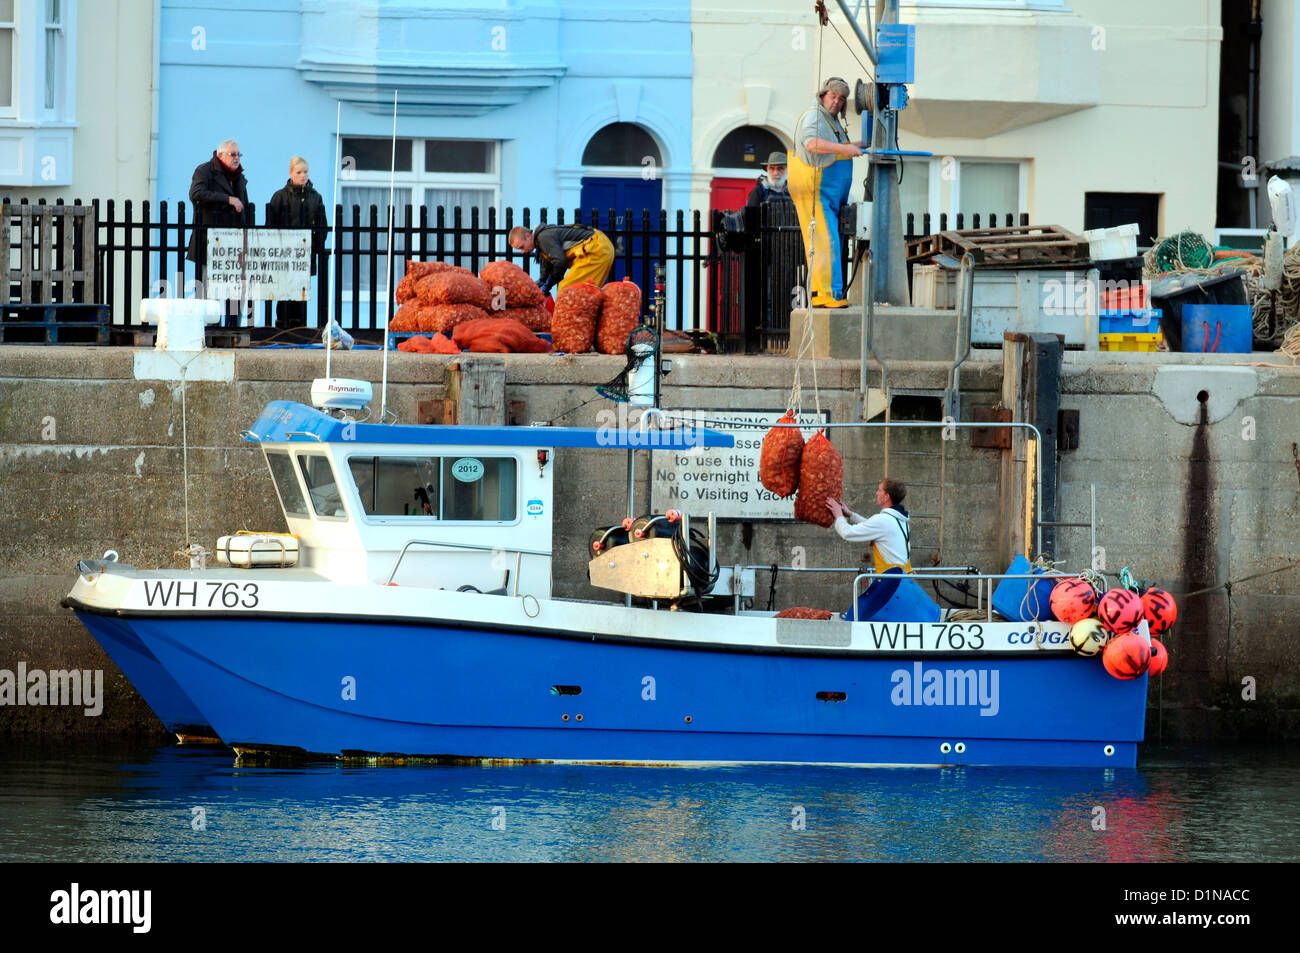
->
(64, 402), (1147, 767)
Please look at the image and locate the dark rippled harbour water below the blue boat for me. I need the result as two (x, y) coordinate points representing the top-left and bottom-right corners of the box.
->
(0, 742), (1300, 862)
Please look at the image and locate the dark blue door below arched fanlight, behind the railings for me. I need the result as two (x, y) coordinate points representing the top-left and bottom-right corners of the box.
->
(581, 176), (663, 286)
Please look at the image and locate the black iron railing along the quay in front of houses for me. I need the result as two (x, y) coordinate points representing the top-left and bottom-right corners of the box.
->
(2, 199), (1028, 351)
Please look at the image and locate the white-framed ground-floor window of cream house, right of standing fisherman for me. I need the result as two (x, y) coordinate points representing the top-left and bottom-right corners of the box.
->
(898, 156), (1030, 234)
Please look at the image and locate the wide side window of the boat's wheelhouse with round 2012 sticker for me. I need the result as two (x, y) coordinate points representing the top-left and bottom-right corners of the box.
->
(347, 456), (519, 523)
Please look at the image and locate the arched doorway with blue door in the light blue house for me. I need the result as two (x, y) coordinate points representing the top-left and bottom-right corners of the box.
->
(581, 122), (663, 282)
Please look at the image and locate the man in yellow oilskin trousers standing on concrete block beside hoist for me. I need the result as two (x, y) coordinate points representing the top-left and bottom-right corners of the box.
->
(789, 77), (865, 308)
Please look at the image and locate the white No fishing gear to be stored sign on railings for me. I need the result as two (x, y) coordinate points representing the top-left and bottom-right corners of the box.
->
(207, 229), (312, 302)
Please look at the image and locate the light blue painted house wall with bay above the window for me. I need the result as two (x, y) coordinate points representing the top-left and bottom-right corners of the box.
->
(153, 0), (692, 221)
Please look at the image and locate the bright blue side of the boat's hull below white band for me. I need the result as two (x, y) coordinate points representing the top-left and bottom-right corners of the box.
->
(122, 616), (1147, 767)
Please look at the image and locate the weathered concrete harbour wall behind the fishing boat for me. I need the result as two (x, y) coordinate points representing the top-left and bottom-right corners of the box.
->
(0, 346), (1300, 741)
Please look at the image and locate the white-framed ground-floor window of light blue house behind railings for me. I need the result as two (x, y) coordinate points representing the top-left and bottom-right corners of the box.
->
(339, 135), (501, 299)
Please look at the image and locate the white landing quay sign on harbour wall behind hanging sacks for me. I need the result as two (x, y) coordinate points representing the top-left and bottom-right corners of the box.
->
(650, 410), (831, 520)
